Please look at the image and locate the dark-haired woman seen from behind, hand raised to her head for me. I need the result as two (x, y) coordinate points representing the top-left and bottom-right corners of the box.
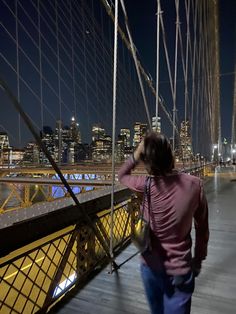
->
(118, 132), (209, 314)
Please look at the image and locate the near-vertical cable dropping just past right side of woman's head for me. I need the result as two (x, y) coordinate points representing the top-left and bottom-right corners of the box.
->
(172, 0), (179, 152)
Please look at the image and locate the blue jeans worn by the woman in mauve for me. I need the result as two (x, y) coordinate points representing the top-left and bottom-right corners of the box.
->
(141, 264), (195, 314)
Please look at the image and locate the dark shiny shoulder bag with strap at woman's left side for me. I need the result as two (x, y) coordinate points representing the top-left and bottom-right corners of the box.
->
(131, 177), (151, 253)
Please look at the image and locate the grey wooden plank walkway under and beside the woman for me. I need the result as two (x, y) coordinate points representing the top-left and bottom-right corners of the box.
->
(52, 168), (236, 314)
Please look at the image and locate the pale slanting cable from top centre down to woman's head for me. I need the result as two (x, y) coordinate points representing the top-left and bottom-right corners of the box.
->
(120, 0), (152, 130)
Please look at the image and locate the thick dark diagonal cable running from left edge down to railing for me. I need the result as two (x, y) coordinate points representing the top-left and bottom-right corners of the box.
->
(0, 77), (117, 269)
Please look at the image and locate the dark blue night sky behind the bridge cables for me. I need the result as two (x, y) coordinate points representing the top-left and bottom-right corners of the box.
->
(0, 0), (236, 146)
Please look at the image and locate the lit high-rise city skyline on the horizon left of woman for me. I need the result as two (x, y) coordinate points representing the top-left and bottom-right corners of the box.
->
(0, 117), (161, 165)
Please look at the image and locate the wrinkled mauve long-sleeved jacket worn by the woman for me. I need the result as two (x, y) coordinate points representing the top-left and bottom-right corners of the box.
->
(118, 158), (209, 275)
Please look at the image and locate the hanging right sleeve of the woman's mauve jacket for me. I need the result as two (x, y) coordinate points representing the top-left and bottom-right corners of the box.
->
(194, 182), (209, 268)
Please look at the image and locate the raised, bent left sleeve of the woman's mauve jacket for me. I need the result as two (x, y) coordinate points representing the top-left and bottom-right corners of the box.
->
(118, 157), (146, 193)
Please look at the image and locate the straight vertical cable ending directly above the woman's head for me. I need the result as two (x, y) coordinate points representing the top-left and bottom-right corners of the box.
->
(155, 0), (161, 132)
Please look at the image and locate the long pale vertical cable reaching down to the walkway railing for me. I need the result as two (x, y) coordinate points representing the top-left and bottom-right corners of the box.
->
(110, 0), (118, 271)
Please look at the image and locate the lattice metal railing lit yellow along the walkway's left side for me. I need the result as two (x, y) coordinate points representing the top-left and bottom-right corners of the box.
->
(0, 164), (214, 313)
